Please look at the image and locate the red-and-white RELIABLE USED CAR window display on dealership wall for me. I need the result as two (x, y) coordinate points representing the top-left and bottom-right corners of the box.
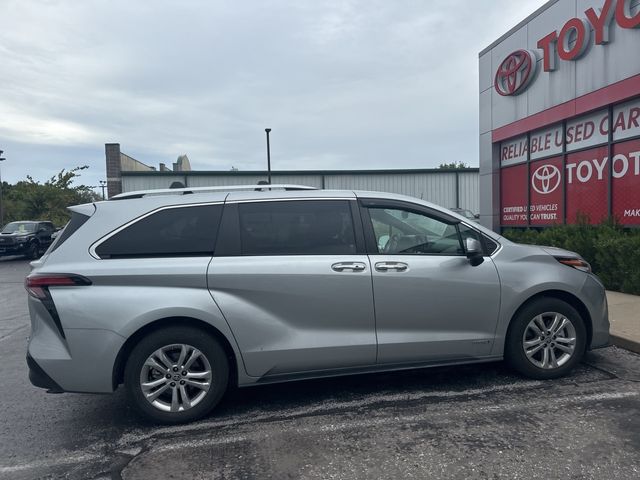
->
(498, 99), (640, 226)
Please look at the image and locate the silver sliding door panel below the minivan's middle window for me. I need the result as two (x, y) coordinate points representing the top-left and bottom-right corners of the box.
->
(208, 255), (376, 376)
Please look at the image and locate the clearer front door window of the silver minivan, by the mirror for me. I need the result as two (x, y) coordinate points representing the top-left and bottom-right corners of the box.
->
(368, 208), (464, 255)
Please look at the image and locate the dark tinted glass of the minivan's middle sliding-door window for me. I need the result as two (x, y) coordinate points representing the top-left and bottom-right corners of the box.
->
(239, 200), (356, 255)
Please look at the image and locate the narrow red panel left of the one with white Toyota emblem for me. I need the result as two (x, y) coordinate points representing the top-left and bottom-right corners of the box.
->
(500, 163), (528, 226)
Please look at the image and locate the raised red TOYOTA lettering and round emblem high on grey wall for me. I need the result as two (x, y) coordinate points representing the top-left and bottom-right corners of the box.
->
(494, 0), (640, 96)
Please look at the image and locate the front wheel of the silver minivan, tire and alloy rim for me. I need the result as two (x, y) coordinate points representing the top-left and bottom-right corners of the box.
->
(505, 298), (587, 380)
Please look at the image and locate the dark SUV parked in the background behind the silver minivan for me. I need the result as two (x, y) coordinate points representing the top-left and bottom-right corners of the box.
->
(0, 221), (55, 258)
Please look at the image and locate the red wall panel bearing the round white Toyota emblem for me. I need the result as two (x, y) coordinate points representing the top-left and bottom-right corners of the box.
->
(529, 157), (564, 225)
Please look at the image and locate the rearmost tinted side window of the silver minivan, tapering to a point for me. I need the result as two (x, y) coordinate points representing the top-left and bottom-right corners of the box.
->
(96, 205), (222, 258)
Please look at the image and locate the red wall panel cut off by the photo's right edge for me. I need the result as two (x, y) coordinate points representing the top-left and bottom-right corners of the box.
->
(612, 140), (640, 225)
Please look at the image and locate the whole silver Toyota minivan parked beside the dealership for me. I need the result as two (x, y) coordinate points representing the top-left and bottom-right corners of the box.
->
(25, 186), (609, 423)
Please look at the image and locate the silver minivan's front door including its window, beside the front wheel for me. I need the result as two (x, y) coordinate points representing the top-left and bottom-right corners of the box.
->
(362, 199), (500, 363)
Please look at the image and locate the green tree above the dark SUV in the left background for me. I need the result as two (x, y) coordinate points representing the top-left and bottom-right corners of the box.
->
(2, 165), (99, 227)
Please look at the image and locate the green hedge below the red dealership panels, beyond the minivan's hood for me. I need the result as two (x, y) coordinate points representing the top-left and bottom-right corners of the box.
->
(503, 219), (640, 295)
